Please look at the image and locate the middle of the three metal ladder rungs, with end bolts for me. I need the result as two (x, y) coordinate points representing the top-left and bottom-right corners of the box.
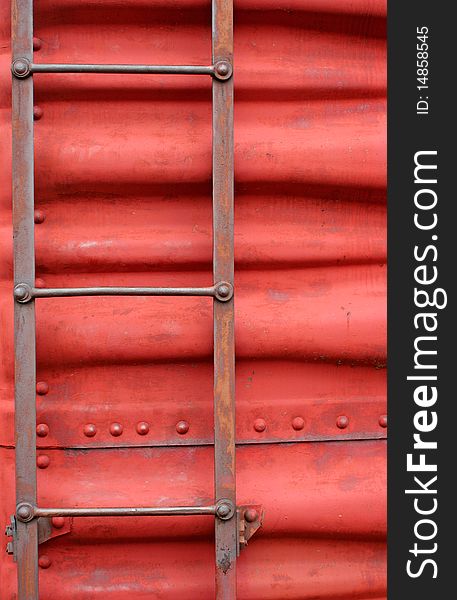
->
(14, 281), (233, 304)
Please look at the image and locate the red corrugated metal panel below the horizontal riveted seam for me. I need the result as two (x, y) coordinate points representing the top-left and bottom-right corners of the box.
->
(0, 440), (385, 600)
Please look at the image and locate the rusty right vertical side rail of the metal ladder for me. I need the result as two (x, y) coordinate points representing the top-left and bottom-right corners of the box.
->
(212, 0), (238, 600)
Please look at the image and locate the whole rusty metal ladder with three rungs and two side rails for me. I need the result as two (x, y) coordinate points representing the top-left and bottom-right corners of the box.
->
(11, 0), (235, 600)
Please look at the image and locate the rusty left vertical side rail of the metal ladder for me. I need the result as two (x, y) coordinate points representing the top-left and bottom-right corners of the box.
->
(12, 0), (38, 600)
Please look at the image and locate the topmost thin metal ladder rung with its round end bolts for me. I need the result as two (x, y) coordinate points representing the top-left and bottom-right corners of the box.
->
(11, 58), (232, 81)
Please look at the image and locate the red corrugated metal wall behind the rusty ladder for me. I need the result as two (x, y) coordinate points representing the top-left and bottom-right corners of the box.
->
(0, 0), (386, 600)
